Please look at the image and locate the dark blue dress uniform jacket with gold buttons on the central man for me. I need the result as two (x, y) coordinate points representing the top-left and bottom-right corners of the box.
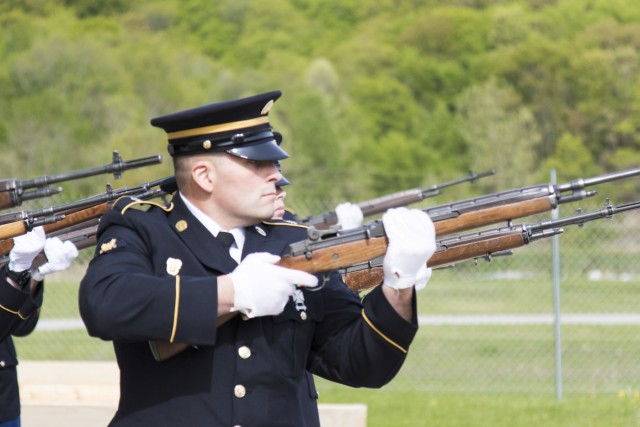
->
(79, 196), (417, 427)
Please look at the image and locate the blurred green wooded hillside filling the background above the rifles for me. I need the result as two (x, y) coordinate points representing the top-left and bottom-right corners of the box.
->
(0, 0), (640, 213)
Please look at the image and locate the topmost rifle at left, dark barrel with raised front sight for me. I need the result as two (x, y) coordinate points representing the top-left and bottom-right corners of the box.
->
(0, 151), (162, 209)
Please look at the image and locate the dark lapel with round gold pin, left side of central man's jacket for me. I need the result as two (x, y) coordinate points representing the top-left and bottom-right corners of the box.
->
(169, 194), (238, 273)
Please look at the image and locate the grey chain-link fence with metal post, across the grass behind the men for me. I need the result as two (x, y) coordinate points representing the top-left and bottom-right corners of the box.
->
(15, 195), (640, 394)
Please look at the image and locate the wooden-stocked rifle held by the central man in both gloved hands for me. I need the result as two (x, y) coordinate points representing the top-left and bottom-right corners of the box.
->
(149, 168), (640, 361)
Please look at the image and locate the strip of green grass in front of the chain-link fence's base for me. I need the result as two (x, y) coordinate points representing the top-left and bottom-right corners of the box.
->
(318, 380), (640, 427)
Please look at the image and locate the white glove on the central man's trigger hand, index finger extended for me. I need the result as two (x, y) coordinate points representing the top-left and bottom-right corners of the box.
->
(229, 252), (318, 317)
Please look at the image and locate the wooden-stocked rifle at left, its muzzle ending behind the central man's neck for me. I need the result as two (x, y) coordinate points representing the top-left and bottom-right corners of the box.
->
(0, 176), (175, 247)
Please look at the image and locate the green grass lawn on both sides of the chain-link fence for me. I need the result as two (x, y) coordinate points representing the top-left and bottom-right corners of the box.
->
(16, 229), (640, 427)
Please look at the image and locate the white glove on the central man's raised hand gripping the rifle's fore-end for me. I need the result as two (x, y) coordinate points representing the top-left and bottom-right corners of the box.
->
(382, 208), (436, 290)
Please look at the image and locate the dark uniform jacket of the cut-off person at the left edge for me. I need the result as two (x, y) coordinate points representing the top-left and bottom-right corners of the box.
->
(0, 278), (44, 422)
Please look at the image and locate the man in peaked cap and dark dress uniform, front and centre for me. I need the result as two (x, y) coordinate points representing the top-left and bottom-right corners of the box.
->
(79, 91), (435, 427)
